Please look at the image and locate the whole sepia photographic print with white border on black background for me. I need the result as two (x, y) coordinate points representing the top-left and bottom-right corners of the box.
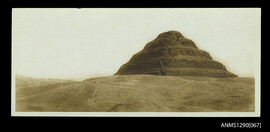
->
(11, 8), (261, 117)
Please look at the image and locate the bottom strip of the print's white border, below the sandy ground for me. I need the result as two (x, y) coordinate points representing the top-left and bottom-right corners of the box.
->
(12, 112), (260, 117)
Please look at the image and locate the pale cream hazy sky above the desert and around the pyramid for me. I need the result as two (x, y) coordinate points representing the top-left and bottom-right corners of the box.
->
(12, 8), (261, 79)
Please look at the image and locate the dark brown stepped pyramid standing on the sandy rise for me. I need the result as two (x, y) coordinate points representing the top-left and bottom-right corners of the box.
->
(115, 31), (237, 78)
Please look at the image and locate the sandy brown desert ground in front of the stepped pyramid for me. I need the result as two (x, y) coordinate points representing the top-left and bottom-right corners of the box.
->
(16, 75), (255, 112)
